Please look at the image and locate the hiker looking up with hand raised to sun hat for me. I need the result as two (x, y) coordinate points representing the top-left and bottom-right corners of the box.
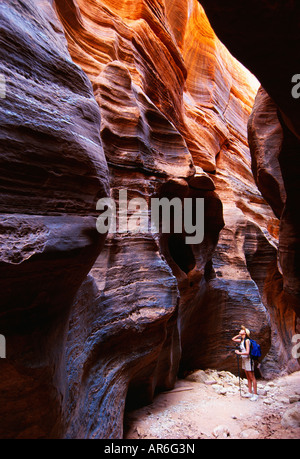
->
(232, 325), (258, 402)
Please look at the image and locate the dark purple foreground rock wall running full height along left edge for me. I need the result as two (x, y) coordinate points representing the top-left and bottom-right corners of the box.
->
(0, 1), (109, 438)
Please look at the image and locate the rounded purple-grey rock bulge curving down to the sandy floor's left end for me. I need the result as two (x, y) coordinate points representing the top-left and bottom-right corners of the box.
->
(65, 235), (180, 438)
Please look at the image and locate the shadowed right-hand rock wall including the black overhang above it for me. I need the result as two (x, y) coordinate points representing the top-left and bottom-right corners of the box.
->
(201, 0), (300, 374)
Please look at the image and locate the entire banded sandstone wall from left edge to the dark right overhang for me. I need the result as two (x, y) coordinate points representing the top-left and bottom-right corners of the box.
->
(0, 0), (299, 438)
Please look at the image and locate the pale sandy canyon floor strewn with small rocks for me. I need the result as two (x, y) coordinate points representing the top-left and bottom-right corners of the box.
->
(124, 370), (300, 439)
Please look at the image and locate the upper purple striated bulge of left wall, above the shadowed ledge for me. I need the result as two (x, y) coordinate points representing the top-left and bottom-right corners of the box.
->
(0, 1), (108, 215)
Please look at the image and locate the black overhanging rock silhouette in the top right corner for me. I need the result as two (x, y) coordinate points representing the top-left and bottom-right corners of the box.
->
(200, 0), (300, 138)
